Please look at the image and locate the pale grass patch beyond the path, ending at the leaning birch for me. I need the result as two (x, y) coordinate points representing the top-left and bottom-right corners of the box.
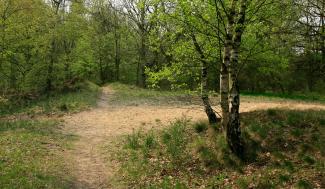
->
(110, 83), (197, 105)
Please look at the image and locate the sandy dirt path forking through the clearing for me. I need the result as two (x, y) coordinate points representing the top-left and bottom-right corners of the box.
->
(64, 86), (325, 189)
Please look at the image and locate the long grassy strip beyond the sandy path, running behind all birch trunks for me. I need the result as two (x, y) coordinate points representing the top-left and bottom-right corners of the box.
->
(110, 83), (325, 105)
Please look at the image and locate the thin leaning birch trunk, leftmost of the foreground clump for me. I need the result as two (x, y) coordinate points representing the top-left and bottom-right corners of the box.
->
(191, 34), (218, 124)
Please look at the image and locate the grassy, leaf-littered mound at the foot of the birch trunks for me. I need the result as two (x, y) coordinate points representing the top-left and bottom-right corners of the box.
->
(116, 109), (325, 189)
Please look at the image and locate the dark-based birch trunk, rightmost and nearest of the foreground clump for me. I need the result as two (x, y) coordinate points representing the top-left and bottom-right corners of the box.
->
(227, 0), (247, 158)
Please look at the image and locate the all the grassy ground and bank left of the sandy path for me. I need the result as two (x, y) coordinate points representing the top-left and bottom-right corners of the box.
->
(0, 82), (100, 189)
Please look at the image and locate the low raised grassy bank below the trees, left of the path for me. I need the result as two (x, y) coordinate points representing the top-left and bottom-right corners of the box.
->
(0, 82), (99, 116)
